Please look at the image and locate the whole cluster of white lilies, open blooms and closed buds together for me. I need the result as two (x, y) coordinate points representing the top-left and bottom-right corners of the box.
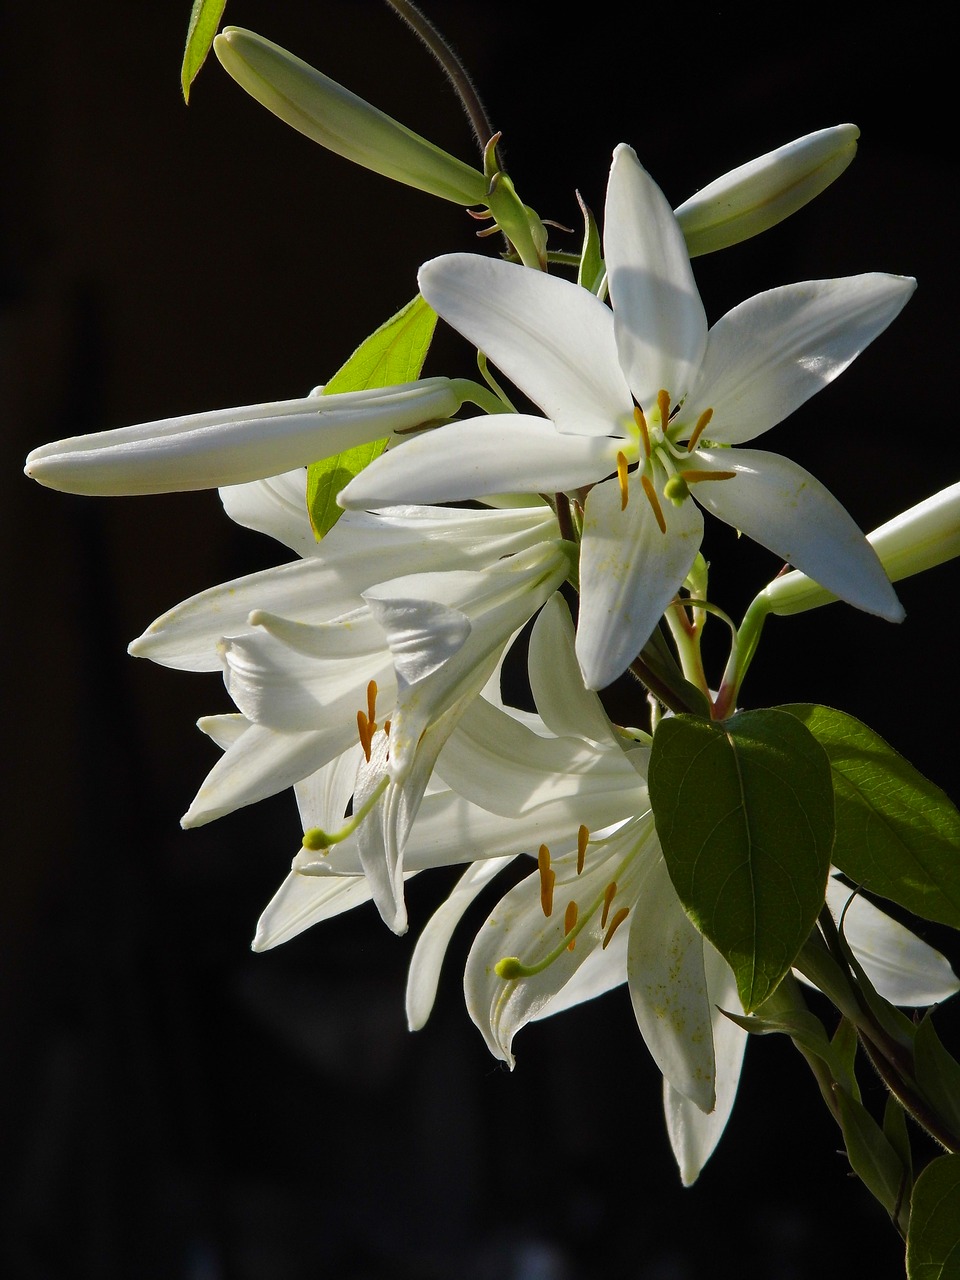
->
(26, 28), (960, 1183)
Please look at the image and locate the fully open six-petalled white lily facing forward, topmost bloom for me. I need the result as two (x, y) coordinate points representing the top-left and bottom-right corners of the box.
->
(339, 146), (915, 689)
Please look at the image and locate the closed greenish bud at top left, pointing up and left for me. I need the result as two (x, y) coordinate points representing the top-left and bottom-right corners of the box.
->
(214, 27), (486, 206)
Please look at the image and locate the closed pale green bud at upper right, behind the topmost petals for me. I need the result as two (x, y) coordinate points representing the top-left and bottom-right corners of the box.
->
(676, 124), (860, 257)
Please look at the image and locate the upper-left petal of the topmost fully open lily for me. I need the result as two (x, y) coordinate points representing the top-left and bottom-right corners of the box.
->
(419, 253), (632, 435)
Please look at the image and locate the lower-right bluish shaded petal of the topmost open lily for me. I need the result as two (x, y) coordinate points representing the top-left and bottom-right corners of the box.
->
(694, 449), (904, 622)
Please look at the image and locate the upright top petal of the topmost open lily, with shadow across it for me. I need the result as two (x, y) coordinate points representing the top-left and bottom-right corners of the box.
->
(603, 145), (707, 406)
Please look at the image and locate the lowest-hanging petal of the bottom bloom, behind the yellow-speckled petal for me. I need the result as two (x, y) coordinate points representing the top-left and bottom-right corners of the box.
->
(663, 943), (748, 1187)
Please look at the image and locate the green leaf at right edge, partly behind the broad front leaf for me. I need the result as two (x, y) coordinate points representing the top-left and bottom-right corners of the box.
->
(781, 704), (960, 928)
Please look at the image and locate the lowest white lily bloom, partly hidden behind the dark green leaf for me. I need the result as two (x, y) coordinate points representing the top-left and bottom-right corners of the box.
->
(396, 598), (957, 1183)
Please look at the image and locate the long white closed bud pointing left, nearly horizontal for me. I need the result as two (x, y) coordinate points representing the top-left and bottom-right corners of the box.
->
(23, 378), (465, 497)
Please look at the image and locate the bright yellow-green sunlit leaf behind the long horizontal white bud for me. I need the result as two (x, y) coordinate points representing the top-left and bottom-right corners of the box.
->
(307, 294), (436, 541)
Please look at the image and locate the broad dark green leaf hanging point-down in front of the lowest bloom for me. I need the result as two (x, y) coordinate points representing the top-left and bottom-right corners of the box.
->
(648, 710), (833, 1012)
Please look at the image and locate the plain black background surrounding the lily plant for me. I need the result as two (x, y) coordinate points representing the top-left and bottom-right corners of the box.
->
(0, 0), (959, 1280)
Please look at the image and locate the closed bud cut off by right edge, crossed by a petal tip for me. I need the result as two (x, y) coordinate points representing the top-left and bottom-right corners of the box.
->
(758, 483), (960, 616)
